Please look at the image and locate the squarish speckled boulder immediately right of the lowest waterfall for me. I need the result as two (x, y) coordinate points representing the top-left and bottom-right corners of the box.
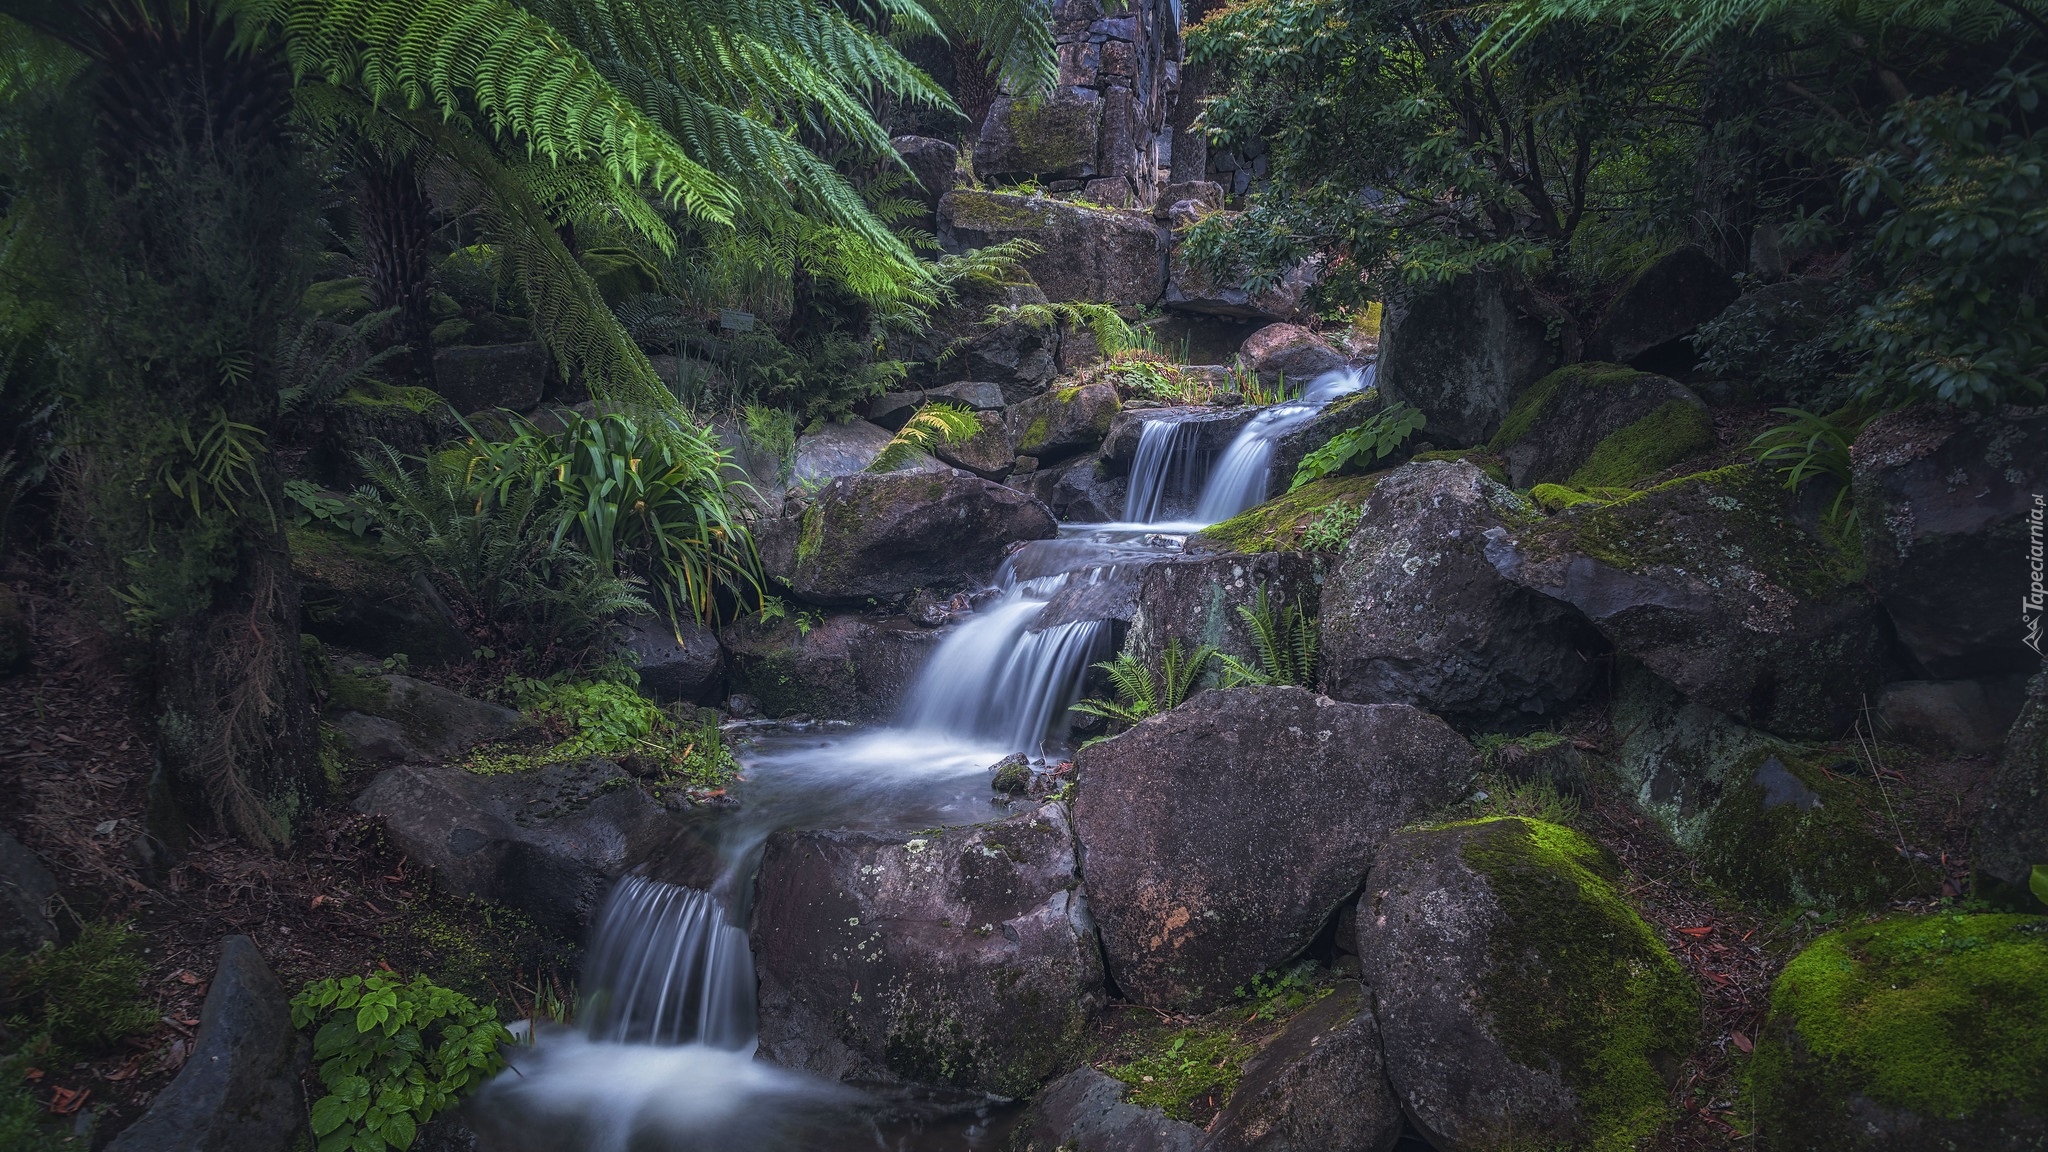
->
(754, 804), (1104, 1097)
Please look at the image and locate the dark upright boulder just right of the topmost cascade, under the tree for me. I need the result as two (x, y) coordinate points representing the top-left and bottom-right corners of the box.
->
(1378, 273), (1559, 447)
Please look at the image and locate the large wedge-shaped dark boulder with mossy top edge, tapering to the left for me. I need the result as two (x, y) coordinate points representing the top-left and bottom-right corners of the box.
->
(1489, 465), (1886, 738)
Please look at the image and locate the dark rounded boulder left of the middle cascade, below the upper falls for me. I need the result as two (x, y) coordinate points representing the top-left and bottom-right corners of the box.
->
(791, 471), (1057, 605)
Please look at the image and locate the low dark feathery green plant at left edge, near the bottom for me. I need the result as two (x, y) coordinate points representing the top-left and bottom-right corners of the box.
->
(0, 920), (156, 1062)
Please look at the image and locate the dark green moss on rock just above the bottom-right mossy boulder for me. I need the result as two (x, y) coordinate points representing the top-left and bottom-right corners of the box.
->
(1696, 748), (1942, 908)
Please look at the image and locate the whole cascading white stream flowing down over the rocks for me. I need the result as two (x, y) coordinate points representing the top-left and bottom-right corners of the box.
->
(465, 369), (1370, 1152)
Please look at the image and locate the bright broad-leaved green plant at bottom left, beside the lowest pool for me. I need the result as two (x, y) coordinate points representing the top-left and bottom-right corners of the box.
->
(291, 974), (512, 1152)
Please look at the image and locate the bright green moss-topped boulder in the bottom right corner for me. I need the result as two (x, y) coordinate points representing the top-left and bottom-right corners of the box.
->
(1745, 912), (2048, 1152)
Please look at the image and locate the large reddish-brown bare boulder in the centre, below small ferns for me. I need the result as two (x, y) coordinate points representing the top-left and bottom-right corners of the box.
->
(1073, 689), (1479, 1011)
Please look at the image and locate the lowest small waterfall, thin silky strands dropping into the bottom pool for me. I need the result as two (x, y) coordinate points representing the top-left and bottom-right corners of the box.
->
(582, 875), (756, 1054)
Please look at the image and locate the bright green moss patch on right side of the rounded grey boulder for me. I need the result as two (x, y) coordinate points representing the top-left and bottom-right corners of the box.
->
(1452, 816), (1700, 1152)
